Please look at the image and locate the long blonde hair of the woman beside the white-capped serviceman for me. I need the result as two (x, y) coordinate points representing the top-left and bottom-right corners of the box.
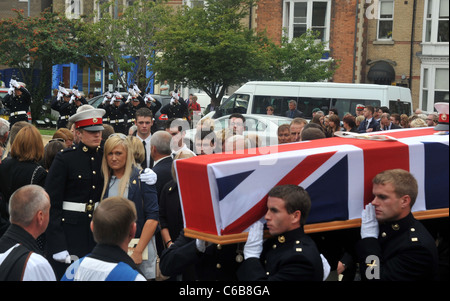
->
(101, 134), (134, 199)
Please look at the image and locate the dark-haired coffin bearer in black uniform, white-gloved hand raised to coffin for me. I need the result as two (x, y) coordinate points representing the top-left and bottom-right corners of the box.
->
(237, 185), (328, 281)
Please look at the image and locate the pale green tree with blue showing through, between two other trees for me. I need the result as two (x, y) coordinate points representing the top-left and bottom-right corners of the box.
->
(82, 0), (170, 91)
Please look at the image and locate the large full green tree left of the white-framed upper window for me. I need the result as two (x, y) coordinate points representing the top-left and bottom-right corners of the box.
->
(154, 0), (273, 105)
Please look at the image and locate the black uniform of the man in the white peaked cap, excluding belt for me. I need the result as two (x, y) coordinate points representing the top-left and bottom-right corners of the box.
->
(45, 142), (103, 258)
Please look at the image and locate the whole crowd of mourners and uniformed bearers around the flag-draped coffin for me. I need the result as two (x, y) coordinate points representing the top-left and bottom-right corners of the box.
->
(0, 82), (448, 281)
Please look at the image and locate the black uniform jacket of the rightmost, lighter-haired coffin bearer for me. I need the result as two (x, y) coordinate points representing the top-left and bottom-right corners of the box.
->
(356, 213), (438, 281)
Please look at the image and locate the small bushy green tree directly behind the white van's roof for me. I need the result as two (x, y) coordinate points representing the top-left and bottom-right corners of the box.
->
(273, 30), (338, 82)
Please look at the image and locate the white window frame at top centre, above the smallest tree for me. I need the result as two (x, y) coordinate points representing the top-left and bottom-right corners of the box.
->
(283, 0), (331, 49)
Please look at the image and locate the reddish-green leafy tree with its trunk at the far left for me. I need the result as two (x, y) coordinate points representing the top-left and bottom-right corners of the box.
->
(0, 9), (85, 119)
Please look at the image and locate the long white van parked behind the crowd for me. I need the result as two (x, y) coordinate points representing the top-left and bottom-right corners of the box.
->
(214, 81), (412, 119)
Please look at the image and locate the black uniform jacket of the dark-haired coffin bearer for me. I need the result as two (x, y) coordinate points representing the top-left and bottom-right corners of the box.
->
(238, 227), (323, 281)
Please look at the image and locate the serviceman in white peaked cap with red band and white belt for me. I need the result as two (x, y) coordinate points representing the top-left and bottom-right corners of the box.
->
(45, 106), (105, 278)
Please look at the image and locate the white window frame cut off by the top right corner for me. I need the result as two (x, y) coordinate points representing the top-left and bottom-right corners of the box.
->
(422, 0), (449, 44)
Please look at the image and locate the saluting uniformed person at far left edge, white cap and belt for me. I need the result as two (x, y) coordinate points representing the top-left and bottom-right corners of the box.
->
(3, 77), (31, 127)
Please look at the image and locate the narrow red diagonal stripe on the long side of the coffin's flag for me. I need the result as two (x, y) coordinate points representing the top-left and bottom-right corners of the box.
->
(221, 152), (336, 235)
